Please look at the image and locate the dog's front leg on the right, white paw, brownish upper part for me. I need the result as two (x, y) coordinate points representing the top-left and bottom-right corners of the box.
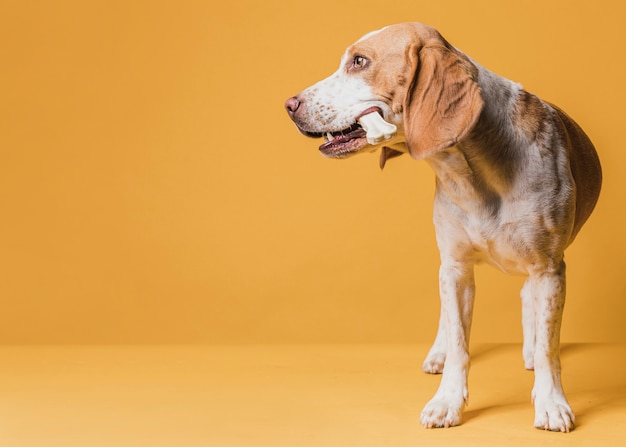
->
(529, 262), (574, 432)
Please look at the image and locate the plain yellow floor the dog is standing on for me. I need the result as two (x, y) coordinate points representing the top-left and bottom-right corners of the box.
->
(0, 344), (626, 447)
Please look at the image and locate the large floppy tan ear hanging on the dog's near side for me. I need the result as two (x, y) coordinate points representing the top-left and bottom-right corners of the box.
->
(404, 41), (484, 159)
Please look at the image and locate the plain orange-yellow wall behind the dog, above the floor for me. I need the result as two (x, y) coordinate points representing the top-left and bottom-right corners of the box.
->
(0, 0), (626, 343)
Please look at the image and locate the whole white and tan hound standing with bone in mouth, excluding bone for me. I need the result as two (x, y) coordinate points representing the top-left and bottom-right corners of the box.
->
(285, 23), (602, 432)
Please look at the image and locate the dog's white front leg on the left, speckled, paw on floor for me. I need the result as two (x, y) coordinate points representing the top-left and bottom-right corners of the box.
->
(421, 260), (474, 428)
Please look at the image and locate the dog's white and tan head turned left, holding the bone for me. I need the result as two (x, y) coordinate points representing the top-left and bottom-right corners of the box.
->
(285, 23), (484, 166)
